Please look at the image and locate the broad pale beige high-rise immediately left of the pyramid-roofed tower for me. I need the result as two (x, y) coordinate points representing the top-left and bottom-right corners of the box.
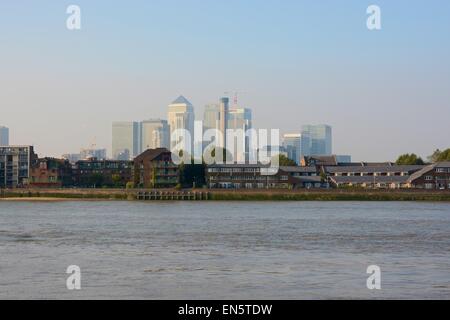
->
(141, 119), (170, 152)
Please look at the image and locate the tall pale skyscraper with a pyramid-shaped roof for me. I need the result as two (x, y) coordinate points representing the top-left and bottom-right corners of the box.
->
(167, 96), (195, 154)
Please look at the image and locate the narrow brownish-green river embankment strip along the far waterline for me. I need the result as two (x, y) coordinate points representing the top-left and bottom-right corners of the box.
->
(0, 189), (450, 202)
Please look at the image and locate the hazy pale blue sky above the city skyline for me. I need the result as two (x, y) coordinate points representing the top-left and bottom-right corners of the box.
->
(0, 0), (450, 161)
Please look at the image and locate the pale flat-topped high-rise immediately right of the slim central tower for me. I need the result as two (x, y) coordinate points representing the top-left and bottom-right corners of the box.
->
(225, 108), (252, 162)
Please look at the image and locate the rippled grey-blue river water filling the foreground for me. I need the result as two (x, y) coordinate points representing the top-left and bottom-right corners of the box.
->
(0, 201), (450, 299)
